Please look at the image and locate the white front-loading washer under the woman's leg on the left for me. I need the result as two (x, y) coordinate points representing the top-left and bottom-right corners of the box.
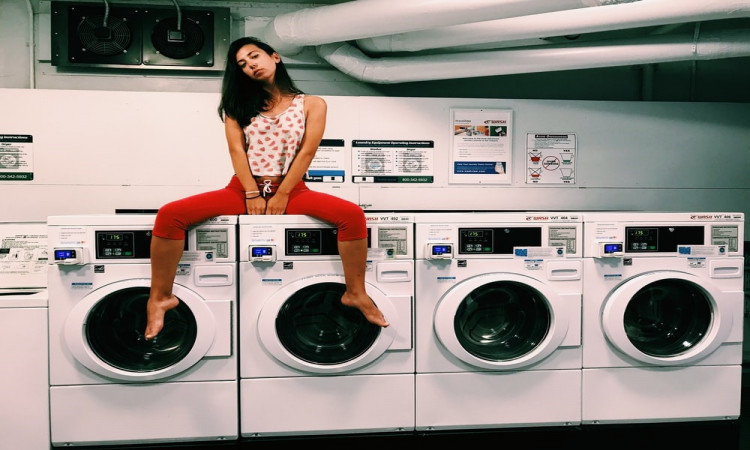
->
(48, 214), (239, 446)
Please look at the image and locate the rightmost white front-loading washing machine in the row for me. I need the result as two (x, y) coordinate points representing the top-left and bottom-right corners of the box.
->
(582, 212), (744, 424)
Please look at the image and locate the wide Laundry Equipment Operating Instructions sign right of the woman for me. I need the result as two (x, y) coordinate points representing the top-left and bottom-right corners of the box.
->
(352, 140), (435, 183)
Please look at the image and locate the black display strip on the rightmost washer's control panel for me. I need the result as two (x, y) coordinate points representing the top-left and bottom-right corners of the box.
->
(625, 226), (705, 253)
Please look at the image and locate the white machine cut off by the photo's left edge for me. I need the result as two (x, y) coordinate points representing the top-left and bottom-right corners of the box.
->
(0, 222), (49, 450)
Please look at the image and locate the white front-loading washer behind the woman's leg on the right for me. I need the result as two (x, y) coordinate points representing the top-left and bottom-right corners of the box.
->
(240, 213), (414, 437)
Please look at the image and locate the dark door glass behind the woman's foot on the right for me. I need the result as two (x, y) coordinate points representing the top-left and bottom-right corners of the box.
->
(276, 282), (380, 365)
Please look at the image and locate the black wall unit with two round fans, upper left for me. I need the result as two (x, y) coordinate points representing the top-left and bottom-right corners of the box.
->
(50, 2), (231, 71)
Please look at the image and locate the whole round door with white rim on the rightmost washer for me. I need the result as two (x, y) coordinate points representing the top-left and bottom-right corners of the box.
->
(601, 271), (733, 366)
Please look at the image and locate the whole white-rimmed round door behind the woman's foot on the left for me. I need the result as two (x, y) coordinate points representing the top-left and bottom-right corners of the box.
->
(64, 279), (216, 382)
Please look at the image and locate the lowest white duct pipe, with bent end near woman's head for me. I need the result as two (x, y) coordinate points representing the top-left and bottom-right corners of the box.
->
(317, 29), (750, 84)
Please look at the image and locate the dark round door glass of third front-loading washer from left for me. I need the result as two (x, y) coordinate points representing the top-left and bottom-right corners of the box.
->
(453, 281), (551, 361)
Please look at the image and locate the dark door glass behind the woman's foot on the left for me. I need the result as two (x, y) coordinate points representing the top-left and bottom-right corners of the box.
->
(84, 287), (197, 372)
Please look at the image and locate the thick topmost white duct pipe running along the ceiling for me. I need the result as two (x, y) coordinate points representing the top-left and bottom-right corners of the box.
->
(263, 0), (638, 55)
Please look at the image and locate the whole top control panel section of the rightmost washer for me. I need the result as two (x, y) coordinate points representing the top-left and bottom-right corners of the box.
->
(583, 212), (744, 258)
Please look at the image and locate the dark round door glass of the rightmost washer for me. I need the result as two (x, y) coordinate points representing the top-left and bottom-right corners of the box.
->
(623, 279), (712, 357)
